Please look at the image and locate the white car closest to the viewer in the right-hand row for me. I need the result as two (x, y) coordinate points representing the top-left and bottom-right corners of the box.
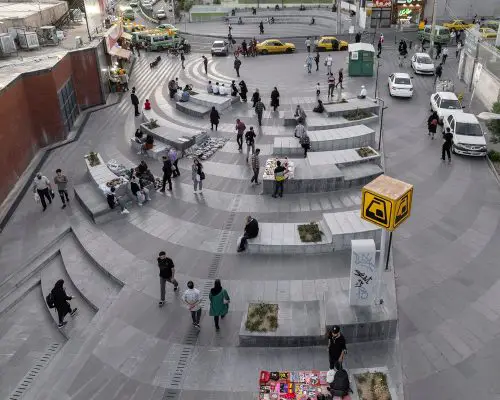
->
(443, 112), (487, 157)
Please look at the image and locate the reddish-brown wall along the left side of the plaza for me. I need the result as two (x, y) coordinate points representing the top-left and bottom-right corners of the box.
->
(0, 49), (104, 203)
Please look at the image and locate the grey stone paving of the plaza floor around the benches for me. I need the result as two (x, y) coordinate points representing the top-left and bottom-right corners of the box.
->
(0, 42), (500, 400)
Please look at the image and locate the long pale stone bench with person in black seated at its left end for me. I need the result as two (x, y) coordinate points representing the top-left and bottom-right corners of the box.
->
(247, 211), (381, 254)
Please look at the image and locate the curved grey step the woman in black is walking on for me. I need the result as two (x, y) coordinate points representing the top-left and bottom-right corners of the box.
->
(41, 255), (95, 339)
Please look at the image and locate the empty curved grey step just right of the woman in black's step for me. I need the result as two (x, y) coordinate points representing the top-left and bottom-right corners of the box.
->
(60, 237), (122, 310)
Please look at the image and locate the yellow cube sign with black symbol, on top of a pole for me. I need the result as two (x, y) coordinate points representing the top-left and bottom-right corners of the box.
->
(361, 175), (413, 231)
